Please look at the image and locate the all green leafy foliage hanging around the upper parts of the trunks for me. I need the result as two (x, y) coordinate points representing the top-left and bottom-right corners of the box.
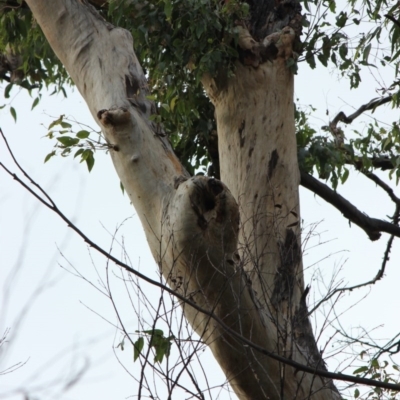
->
(0, 0), (400, 184)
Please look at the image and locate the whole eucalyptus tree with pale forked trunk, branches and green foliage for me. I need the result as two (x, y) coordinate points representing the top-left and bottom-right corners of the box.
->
(0, 0), (400, 399)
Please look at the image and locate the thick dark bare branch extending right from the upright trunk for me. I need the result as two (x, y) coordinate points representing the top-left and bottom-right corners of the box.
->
(301, 171), (400, 241)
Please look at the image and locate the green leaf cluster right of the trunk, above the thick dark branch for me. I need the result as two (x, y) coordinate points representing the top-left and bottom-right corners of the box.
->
(295, 104), (400, 189)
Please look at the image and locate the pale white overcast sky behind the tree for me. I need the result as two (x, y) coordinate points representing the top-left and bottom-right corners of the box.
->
(0, 40), (400, 400)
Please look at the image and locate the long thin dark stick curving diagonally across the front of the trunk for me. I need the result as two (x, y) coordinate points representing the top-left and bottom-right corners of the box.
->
(0, 128), (400, 391)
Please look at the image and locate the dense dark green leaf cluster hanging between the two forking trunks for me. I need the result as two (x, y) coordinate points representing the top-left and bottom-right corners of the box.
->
(99, 0), (248, 174)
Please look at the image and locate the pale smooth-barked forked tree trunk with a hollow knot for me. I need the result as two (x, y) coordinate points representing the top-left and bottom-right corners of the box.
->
(27, 0), (339, 400)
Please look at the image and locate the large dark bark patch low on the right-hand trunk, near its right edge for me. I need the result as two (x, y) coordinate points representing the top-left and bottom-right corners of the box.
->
(271, 229), (301, 309)
